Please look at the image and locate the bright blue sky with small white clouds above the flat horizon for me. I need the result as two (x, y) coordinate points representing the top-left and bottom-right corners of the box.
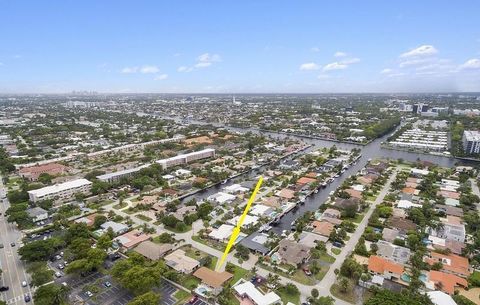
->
(0, 0), (480, 93)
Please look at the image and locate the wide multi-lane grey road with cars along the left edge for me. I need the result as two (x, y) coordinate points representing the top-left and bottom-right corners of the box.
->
(0, 176), (32, 304)
